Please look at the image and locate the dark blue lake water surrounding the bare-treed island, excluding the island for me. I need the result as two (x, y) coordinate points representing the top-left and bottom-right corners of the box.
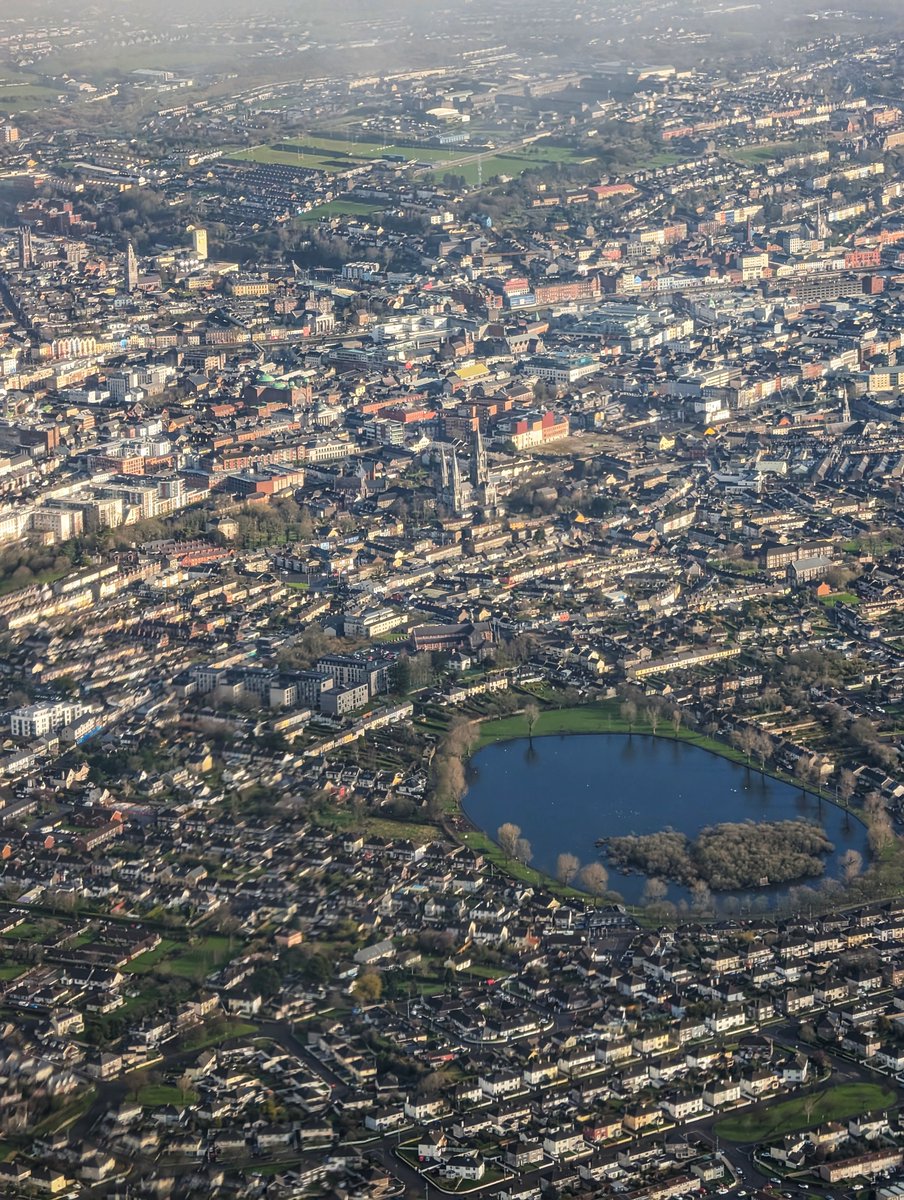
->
(462, 733), (868, 902)
